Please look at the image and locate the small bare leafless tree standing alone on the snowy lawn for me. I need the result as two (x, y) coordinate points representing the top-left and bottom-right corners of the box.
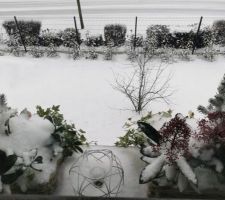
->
(113, 49), (173, 112)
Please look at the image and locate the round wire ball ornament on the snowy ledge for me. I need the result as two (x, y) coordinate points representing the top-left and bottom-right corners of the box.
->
(69, 149), (124, 197)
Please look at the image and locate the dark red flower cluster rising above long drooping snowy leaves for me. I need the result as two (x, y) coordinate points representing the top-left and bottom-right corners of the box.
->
(154, 114), (191, 164)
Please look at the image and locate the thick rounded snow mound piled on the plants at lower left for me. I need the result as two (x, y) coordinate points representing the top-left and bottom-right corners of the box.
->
(0, 111), (57, 192)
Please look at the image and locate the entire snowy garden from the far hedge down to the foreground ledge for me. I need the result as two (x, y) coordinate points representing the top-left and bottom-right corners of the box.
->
(0, 3), (225, 197)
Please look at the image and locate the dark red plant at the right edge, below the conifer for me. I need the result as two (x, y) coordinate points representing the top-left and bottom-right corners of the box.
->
(196, 111), (225, 144)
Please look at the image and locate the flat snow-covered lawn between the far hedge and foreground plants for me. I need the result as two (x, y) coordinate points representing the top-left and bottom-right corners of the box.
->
(0, 55), (225, 145)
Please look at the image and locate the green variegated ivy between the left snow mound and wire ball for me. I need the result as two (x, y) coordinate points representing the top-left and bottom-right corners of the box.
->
(37, 106), (86, 157)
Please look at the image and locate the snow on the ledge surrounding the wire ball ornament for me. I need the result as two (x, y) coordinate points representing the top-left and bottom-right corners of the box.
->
(54, 146), (148, 198)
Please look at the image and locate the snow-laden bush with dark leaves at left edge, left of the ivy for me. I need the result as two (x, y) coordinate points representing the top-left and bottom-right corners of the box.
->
(0, 94), (51, 193)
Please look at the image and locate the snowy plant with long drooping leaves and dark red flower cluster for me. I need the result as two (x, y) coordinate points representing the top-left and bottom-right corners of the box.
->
(138, 114), (225, 192)
